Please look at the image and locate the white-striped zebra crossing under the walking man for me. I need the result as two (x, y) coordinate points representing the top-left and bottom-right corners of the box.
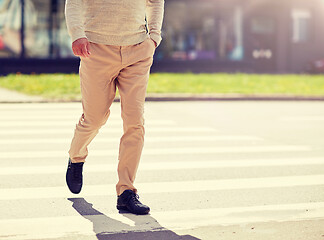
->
(0, 103), (324, 240)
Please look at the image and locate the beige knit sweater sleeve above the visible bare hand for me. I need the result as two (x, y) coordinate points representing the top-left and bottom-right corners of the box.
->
(65, 0), (86, 42)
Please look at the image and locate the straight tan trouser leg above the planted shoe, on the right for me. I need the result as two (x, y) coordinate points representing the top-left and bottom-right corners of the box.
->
(116, 39), (155, 195)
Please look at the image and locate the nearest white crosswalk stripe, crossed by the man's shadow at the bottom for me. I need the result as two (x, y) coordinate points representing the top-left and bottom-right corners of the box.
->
(0, 203), (324, 239)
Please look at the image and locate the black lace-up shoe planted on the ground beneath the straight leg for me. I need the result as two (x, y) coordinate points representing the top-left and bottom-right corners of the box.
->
(117, 190), (150, 215)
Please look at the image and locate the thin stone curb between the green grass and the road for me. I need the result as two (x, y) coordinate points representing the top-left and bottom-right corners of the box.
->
(0, 94), (324, 103)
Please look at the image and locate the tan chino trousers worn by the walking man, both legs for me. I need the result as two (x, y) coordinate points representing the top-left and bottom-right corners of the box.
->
(69, 37), (155, 195)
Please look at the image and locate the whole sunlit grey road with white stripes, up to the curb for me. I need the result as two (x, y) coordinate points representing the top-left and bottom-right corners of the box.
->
(0, 101), (324, 240)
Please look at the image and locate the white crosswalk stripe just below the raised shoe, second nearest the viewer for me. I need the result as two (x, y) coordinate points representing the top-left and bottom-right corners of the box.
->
(0, 175), (324, 200)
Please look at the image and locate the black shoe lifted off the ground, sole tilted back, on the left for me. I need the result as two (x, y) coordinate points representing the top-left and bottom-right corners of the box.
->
(66, 159), (83, 194)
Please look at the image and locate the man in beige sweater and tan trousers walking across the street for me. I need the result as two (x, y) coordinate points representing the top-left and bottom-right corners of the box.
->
(65, 0), (164, 214)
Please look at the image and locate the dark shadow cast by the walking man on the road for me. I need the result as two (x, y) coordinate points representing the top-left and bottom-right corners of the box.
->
(68, 198), (199, 240)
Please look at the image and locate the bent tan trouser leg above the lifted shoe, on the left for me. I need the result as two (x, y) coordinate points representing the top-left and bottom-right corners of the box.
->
(69, 43), (121, 163)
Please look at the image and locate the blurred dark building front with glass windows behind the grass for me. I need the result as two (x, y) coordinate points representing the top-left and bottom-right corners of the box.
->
(0, 0), (324, 74)
